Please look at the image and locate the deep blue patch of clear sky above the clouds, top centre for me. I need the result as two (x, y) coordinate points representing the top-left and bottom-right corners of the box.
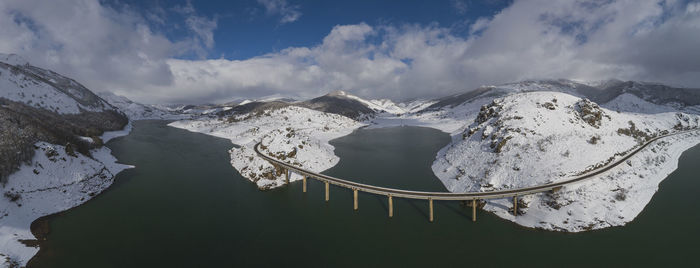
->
(105, 0), (510, 59)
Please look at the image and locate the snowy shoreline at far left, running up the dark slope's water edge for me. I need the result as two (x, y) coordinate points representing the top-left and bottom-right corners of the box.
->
(3, 122), (135, 267)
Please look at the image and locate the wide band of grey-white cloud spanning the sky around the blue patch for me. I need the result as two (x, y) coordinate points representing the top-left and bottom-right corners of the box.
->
(0, 0), (700, 102)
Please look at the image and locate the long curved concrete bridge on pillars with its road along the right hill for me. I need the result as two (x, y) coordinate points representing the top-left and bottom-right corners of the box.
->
(254, 129), (697, 222)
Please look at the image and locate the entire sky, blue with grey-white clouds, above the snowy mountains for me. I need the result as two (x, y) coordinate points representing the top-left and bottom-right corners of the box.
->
(0, 0), (700, 104)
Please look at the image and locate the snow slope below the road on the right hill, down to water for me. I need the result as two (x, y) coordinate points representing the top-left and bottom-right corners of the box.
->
(484, 132), (700, 232)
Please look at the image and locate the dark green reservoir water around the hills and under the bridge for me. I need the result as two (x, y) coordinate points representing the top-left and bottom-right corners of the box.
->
(33, 121), (700, 267)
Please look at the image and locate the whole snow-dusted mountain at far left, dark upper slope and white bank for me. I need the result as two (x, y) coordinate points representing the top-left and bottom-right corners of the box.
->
(0, 54), (128, 266)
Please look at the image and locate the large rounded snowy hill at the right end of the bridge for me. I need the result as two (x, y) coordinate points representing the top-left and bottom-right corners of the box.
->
(433, 92), (700, 231)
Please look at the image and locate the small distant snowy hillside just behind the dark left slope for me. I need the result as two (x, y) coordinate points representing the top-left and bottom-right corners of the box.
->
(98, 92), (191, 120)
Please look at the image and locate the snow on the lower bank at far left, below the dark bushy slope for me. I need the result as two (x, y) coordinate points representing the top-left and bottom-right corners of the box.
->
(0, 142), (130, 267)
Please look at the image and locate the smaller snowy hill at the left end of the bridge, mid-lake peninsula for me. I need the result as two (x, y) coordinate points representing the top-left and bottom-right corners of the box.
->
(170, 106), (363, 189)
